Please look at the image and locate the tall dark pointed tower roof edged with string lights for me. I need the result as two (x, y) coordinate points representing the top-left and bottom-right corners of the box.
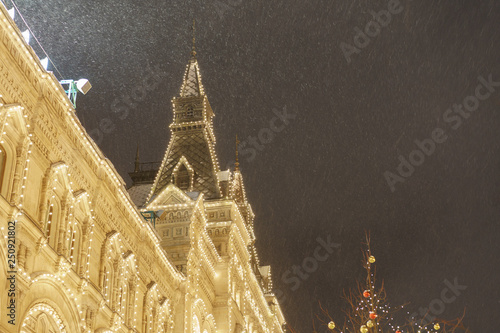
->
(148, 33), (222, 201)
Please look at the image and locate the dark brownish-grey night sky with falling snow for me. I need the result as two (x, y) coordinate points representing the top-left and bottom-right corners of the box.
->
(4, 0), (500, 333)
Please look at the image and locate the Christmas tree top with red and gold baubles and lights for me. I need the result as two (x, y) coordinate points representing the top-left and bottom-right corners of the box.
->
(290, 234), (470, 333)
